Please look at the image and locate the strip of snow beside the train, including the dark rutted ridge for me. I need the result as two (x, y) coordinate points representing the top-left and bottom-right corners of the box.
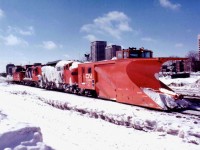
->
(0, 82), (200, 144)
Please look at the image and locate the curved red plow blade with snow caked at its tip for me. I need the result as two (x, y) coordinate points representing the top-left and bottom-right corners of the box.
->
(116, 58), (188, 110)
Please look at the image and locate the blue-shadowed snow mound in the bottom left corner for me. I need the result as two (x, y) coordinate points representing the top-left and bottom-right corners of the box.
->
(0, 111), (52, 150)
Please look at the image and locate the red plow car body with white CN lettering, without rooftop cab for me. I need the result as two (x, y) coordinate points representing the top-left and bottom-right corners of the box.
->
(79, 58), (188, 110)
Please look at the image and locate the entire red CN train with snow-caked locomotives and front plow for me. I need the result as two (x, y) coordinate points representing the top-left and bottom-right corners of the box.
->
(6, 48), (186, 110)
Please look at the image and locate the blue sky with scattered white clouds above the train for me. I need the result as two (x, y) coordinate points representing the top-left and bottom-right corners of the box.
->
(0, 0), (200, 72)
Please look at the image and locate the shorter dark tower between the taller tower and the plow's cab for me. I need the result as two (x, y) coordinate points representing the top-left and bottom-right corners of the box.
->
(105, 45), (121, 60)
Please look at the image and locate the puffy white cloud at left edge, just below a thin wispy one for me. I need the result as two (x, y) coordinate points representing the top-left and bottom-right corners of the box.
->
(0, 34), (28, 46)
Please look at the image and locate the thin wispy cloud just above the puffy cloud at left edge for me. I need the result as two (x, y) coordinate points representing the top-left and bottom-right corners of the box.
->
(7, 26), (35, 36)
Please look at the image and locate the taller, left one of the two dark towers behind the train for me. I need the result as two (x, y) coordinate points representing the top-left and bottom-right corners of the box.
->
(91, 41), (107, 62)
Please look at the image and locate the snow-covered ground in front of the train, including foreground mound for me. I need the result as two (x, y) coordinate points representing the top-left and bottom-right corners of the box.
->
(0, 78), (200, 150)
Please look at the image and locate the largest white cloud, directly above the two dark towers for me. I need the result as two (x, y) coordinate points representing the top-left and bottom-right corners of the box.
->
(81, 11), (133, 39)
